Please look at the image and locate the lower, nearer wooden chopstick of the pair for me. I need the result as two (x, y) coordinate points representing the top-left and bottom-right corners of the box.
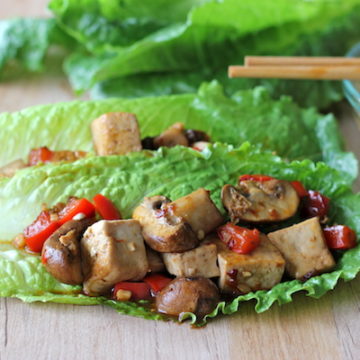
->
(228, 65), (360, 80)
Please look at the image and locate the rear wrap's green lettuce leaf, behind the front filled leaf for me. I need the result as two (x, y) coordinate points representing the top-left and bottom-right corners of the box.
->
(0, 82), (357, 181)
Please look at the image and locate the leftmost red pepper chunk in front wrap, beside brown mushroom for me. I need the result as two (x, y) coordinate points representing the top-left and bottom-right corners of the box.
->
(24, 211), (60, 252)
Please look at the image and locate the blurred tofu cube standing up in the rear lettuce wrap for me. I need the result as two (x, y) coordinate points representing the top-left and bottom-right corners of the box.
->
(91, 112), (142, 156)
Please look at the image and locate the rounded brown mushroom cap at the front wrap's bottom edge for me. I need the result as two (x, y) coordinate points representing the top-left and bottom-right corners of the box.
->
(156, 277), (220, 318)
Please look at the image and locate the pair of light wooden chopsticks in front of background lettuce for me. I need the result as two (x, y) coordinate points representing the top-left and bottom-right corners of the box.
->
(228, 56), (360, 80)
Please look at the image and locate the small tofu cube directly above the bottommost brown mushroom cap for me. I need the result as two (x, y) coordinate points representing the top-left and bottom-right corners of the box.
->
(162, 244), (220, 278)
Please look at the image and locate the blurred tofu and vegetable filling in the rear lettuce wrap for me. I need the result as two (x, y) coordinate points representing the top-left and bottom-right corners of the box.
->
(0, 112), (210, 177)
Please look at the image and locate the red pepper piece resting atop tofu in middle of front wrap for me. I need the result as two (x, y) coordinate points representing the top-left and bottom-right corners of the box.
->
(217, 223), (260, 254)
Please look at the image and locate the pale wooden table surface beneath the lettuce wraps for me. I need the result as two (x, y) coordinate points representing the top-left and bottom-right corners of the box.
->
(0, 0), (360, 360)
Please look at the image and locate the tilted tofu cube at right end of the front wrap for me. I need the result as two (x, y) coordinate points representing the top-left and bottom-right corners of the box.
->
(268, 217), (335, 280)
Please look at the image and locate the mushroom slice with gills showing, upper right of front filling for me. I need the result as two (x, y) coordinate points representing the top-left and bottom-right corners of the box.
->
(221, 179), (300, 223)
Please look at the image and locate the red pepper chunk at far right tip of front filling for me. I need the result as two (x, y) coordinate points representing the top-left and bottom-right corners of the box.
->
(324, 225), (356, 250)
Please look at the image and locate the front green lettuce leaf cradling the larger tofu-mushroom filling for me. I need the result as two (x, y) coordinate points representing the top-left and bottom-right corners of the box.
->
(0, 143), (360, 324)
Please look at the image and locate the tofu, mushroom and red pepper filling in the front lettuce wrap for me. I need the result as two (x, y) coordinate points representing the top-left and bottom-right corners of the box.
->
(14, 176), (356, 318)
